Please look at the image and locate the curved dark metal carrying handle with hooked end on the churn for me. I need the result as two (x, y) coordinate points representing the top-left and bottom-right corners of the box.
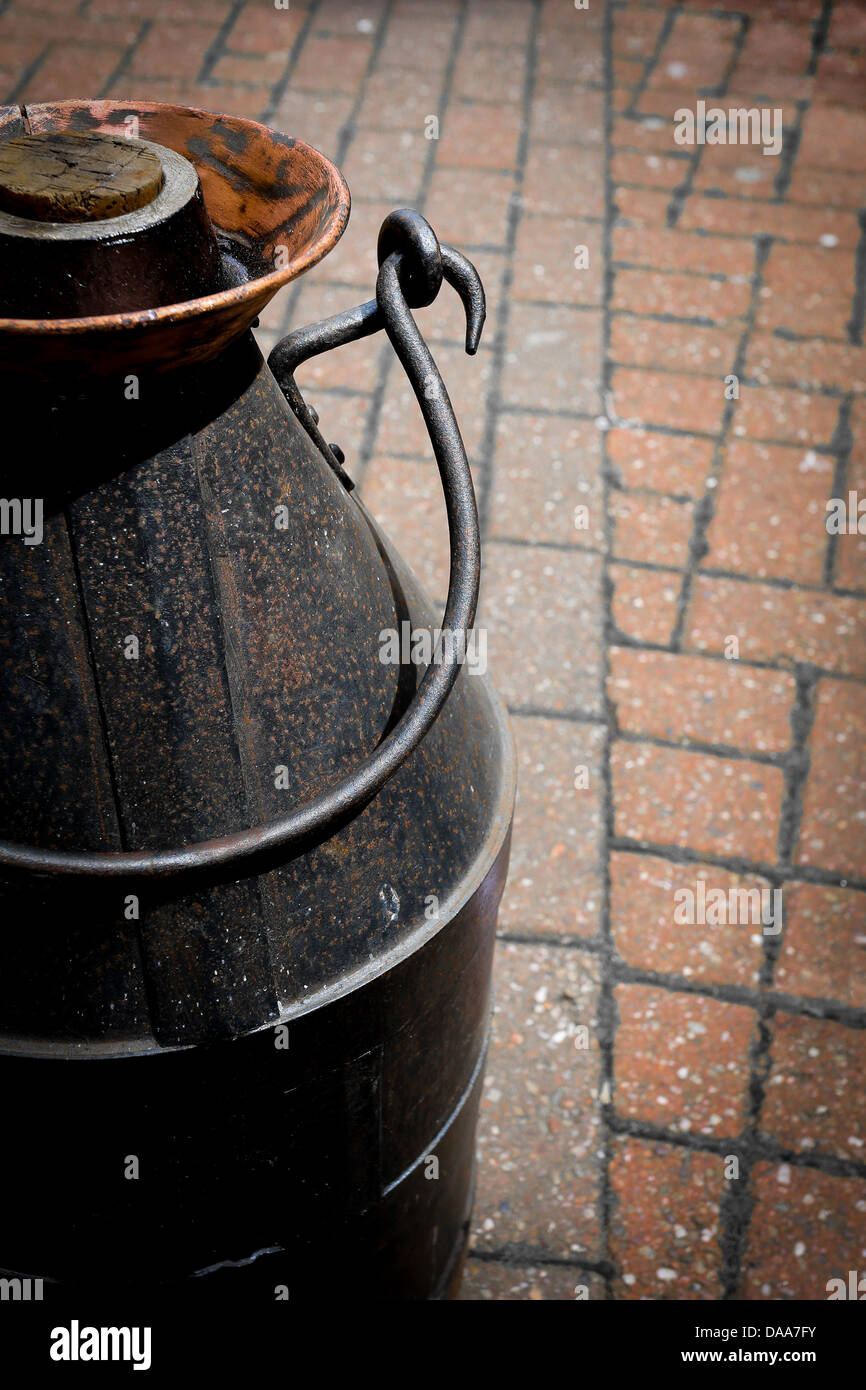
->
(0, 210), (485, 877)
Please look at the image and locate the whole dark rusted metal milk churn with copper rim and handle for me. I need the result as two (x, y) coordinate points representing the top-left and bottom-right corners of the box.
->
(0, 101), (514, 1301)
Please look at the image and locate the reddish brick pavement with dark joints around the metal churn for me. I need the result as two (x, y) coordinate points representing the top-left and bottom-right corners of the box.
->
(0, 0), (866, 1300)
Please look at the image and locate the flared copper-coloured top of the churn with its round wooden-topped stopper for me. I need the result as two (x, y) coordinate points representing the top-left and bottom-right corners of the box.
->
(0, 100), (349, 375)
